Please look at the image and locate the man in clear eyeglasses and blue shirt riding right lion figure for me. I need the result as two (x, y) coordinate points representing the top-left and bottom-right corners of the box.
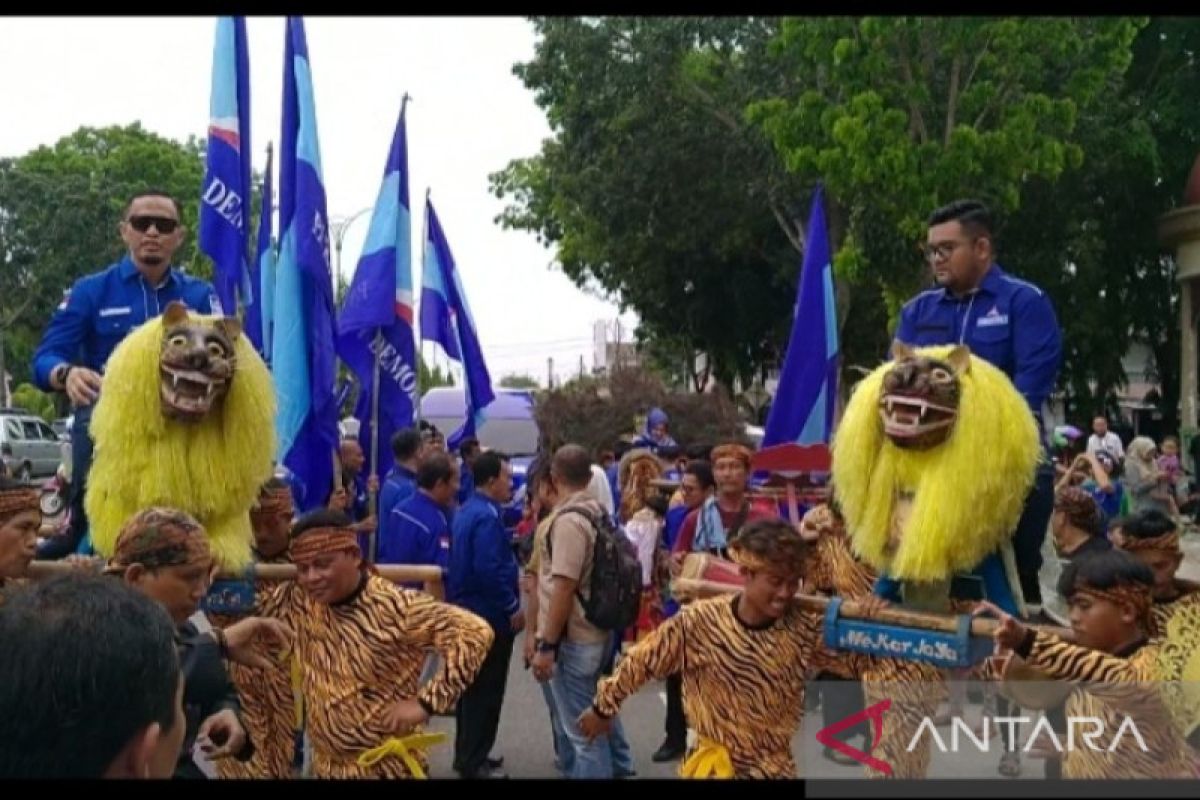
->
(895, 200), (1062, 613)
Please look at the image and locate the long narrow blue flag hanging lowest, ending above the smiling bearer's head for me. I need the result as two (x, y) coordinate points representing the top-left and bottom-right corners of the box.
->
(271, 17), (337, 511)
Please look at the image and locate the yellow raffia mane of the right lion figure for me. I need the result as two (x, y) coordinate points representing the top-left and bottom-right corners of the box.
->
(833, 347), (1042, 582)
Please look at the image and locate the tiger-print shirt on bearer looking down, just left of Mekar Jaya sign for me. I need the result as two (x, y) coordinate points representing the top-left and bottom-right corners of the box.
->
(595, 594), (821, 778)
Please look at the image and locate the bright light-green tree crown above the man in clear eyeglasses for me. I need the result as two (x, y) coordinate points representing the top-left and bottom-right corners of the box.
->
(748, 17), (1145, 319)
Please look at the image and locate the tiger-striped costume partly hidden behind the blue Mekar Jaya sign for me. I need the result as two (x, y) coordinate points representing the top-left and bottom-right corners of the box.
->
(805, 507), (947, 778)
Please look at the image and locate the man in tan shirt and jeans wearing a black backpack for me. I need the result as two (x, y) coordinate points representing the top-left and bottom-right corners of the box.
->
(530, 445), (642, 778)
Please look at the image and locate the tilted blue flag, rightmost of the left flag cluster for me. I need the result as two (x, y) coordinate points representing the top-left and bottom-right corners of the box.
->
(421, 199), (496, 449)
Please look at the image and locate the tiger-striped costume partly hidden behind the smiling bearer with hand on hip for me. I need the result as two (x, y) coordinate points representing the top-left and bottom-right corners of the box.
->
(208, 553), (296, 780)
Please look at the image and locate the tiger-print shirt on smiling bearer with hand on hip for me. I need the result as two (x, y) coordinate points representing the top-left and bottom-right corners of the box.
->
(260, 575), (493, 778)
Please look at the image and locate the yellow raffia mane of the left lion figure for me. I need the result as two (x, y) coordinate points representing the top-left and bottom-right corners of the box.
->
(84, 312), (275, 570)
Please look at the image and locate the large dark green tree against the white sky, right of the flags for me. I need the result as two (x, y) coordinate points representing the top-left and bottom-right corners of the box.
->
(492, 18), (802, 391)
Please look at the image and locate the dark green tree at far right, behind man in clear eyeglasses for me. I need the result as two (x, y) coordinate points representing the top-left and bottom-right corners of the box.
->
(1001, 18), (1200, 433)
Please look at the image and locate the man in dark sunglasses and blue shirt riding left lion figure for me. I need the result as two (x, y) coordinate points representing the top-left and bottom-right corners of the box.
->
(34, 191), (221, 558)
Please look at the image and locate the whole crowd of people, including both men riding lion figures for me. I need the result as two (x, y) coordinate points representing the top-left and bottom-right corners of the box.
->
(0, 192), (1200, 778)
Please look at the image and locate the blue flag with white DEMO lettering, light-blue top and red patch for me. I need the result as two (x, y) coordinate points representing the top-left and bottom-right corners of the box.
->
(337, 96), (418, 476)
